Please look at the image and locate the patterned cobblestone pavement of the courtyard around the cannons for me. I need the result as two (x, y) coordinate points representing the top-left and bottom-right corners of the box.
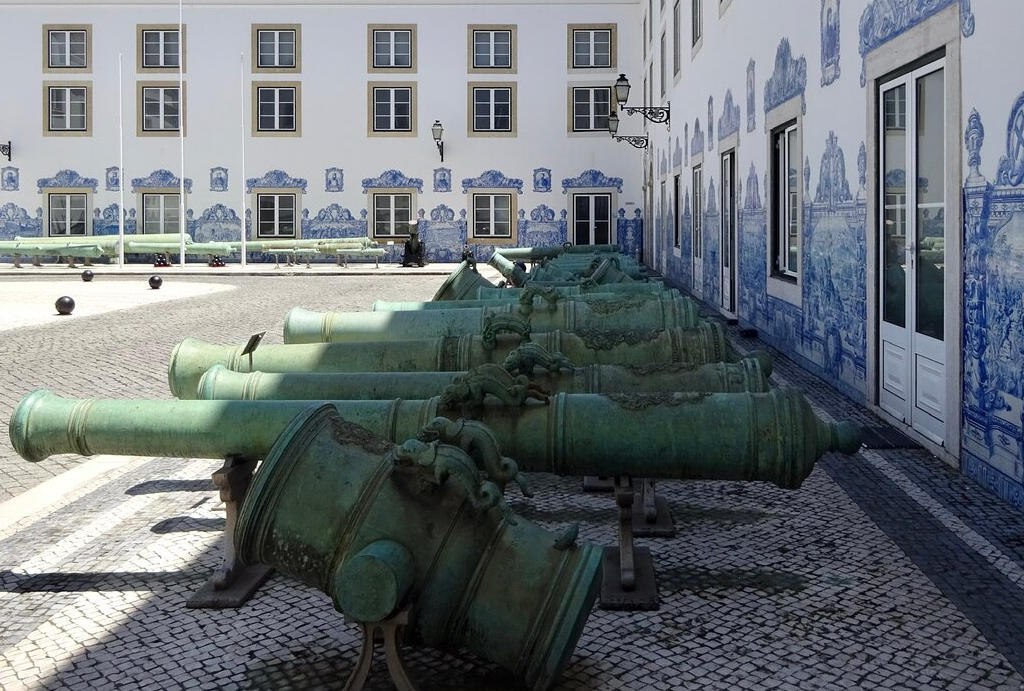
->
(0, 277), (1024, 691)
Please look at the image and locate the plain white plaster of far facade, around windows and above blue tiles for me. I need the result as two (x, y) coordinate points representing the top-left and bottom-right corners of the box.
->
(0, 1), (640, 260)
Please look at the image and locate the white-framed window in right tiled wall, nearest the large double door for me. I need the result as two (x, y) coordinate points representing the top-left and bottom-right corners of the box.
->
(771, 122), (800, 279)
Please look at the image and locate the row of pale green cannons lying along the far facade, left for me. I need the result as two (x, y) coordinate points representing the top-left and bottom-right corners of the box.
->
(0, 232), (387, 268)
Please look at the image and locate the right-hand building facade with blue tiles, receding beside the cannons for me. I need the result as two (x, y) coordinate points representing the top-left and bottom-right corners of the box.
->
(633, 0), (1024, 507)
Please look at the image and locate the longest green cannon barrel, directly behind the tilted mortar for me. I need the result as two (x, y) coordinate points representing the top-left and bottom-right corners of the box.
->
(9, 388), (860, 487)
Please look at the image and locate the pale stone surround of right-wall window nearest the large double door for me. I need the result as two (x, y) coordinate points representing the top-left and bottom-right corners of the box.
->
(765, 94), (806, 307)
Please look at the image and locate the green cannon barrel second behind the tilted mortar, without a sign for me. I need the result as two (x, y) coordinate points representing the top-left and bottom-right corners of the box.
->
(193, 357), (768, 400)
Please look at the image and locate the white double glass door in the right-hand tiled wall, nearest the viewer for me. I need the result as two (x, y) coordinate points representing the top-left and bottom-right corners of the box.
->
(879, 60), (952, 444)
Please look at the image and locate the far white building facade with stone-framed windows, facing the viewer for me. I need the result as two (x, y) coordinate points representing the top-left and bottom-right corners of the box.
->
(0, 0), (642, 261)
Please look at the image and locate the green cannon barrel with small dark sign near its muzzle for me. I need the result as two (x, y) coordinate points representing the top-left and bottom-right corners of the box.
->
(167, 321), (741, 397)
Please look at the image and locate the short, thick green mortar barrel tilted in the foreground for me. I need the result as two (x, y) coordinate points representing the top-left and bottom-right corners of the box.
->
(234, 404), (601, 691)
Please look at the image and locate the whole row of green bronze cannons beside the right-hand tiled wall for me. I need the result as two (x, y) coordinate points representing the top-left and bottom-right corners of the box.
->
(10, 247), (859, 690)
